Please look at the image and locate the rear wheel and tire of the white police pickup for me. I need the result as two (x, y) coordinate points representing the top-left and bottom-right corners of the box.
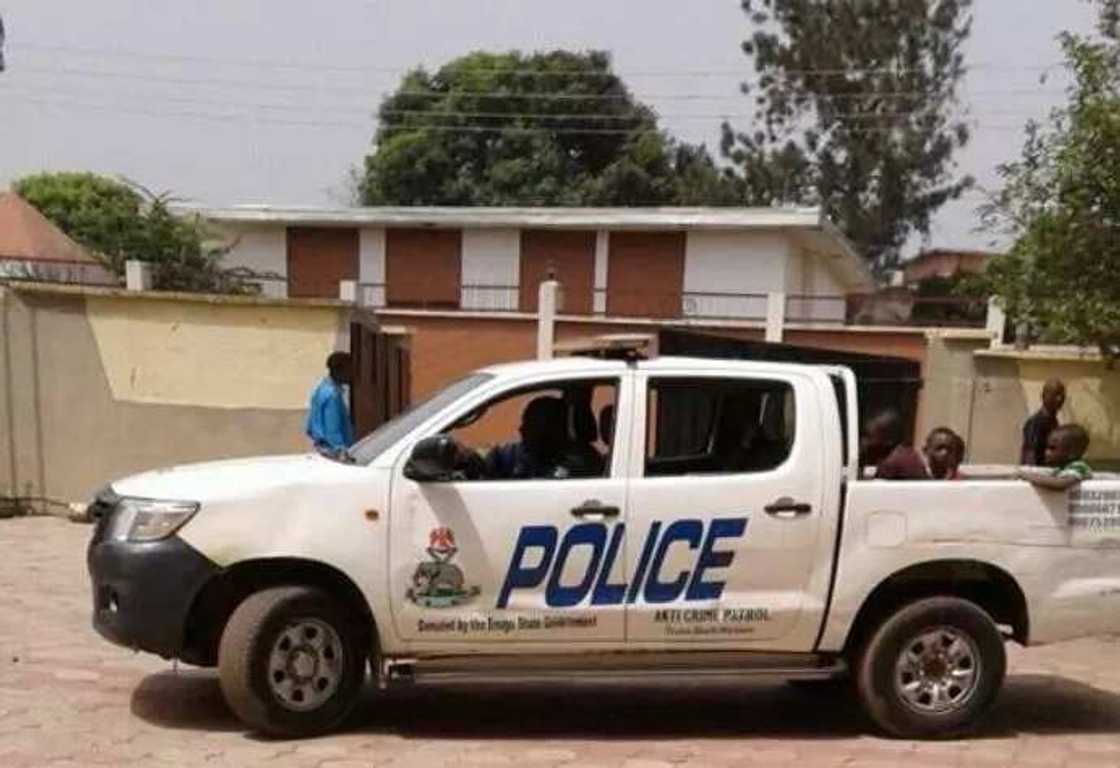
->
(853, 597), (1007, 739)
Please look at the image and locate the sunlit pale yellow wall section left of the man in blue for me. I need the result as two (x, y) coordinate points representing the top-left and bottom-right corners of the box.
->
(86, 296), (340, 409)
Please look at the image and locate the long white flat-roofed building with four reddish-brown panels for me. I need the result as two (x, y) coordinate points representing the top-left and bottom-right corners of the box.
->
(185, 206), (871, 322)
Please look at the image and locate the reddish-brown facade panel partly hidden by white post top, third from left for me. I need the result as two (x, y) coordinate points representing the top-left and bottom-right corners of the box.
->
(520, 230), (595, 315)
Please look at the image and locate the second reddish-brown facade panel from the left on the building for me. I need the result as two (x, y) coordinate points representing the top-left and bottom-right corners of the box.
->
(385, 230), (463, 308)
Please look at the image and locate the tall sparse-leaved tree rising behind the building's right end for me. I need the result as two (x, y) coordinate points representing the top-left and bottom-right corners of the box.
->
(721, 0), (972, 269)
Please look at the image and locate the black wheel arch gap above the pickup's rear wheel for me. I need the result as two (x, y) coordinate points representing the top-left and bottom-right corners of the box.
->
(844, 559), (1030, 653)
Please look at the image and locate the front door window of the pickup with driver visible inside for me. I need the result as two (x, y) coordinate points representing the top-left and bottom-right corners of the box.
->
(442, 380), (618, 480)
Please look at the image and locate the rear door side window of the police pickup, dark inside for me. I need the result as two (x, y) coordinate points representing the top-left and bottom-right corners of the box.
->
(645, 378), (796, 477)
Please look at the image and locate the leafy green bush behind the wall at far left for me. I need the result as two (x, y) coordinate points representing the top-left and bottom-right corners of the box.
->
(12, 172), (250, 293)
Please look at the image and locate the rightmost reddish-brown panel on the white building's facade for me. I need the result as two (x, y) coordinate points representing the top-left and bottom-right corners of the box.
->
(607, 232), (684, 317)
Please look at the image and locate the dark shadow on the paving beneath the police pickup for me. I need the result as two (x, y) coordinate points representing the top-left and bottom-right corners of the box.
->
(131, 671), (1120, 739)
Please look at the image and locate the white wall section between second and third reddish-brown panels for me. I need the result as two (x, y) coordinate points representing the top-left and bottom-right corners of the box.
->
(460, 230), (521, 309)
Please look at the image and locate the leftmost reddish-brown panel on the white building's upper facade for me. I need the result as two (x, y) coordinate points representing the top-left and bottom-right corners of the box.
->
(288, 226), (357, 299)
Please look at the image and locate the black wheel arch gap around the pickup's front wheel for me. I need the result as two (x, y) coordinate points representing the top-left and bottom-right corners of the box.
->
(179, 558), (380, 666)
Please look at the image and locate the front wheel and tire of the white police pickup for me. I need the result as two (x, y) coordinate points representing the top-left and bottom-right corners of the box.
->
(217, 587), (367, 738)
